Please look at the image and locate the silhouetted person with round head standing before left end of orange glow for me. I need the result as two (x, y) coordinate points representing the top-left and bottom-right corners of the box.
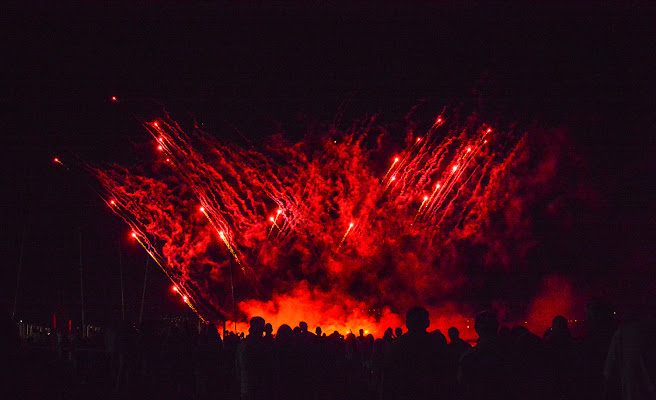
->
(236, 317), (273, 400)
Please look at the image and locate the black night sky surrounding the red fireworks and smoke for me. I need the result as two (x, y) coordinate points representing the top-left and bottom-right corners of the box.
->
(0, 2), (656, 320)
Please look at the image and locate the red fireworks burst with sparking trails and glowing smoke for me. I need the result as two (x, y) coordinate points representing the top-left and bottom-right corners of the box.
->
(88, 107), (580, 335)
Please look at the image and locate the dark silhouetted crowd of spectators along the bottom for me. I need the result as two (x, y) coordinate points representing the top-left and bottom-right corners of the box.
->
(1, 301), (656, 400)
